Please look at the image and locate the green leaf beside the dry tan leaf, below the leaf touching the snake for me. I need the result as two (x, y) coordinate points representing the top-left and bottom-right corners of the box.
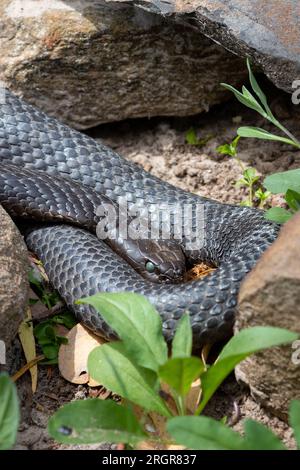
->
(88, 341), (171, 417)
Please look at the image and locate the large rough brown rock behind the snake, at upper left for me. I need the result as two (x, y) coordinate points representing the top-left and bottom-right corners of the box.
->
(0, 0), (246, 129)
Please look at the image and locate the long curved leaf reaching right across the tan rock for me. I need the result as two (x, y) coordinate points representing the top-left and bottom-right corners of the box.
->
(197, 326), (298, 414)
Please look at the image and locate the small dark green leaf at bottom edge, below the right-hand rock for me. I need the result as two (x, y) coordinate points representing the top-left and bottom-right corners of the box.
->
(244, 419), (287, 450)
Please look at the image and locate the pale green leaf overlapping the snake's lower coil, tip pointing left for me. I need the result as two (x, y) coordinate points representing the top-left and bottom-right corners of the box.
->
(78, 292), (168, 371)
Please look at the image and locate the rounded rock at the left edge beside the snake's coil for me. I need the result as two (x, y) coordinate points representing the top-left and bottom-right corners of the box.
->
(0, 206), (28, 352)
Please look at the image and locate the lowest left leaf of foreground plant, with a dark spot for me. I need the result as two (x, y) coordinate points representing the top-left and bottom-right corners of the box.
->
(48, 398), (145, 444)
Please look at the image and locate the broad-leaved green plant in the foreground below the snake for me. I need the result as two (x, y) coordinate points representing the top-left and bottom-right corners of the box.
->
(48, 293), (298, 449)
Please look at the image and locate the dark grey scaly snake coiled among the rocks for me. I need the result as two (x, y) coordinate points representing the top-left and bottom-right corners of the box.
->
(0, 89), (279, 347)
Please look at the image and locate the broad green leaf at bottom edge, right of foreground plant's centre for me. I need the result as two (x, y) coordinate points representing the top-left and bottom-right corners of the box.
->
(167, 416), (245, 450)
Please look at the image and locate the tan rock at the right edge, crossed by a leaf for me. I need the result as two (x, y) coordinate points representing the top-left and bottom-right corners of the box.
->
(236, 213), (300, 419)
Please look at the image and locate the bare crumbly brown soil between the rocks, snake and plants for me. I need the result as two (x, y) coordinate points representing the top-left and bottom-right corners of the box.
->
(14, 82), (300, 449)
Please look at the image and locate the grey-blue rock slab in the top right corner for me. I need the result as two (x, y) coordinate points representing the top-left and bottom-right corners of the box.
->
(132, 0), (300, 92)
